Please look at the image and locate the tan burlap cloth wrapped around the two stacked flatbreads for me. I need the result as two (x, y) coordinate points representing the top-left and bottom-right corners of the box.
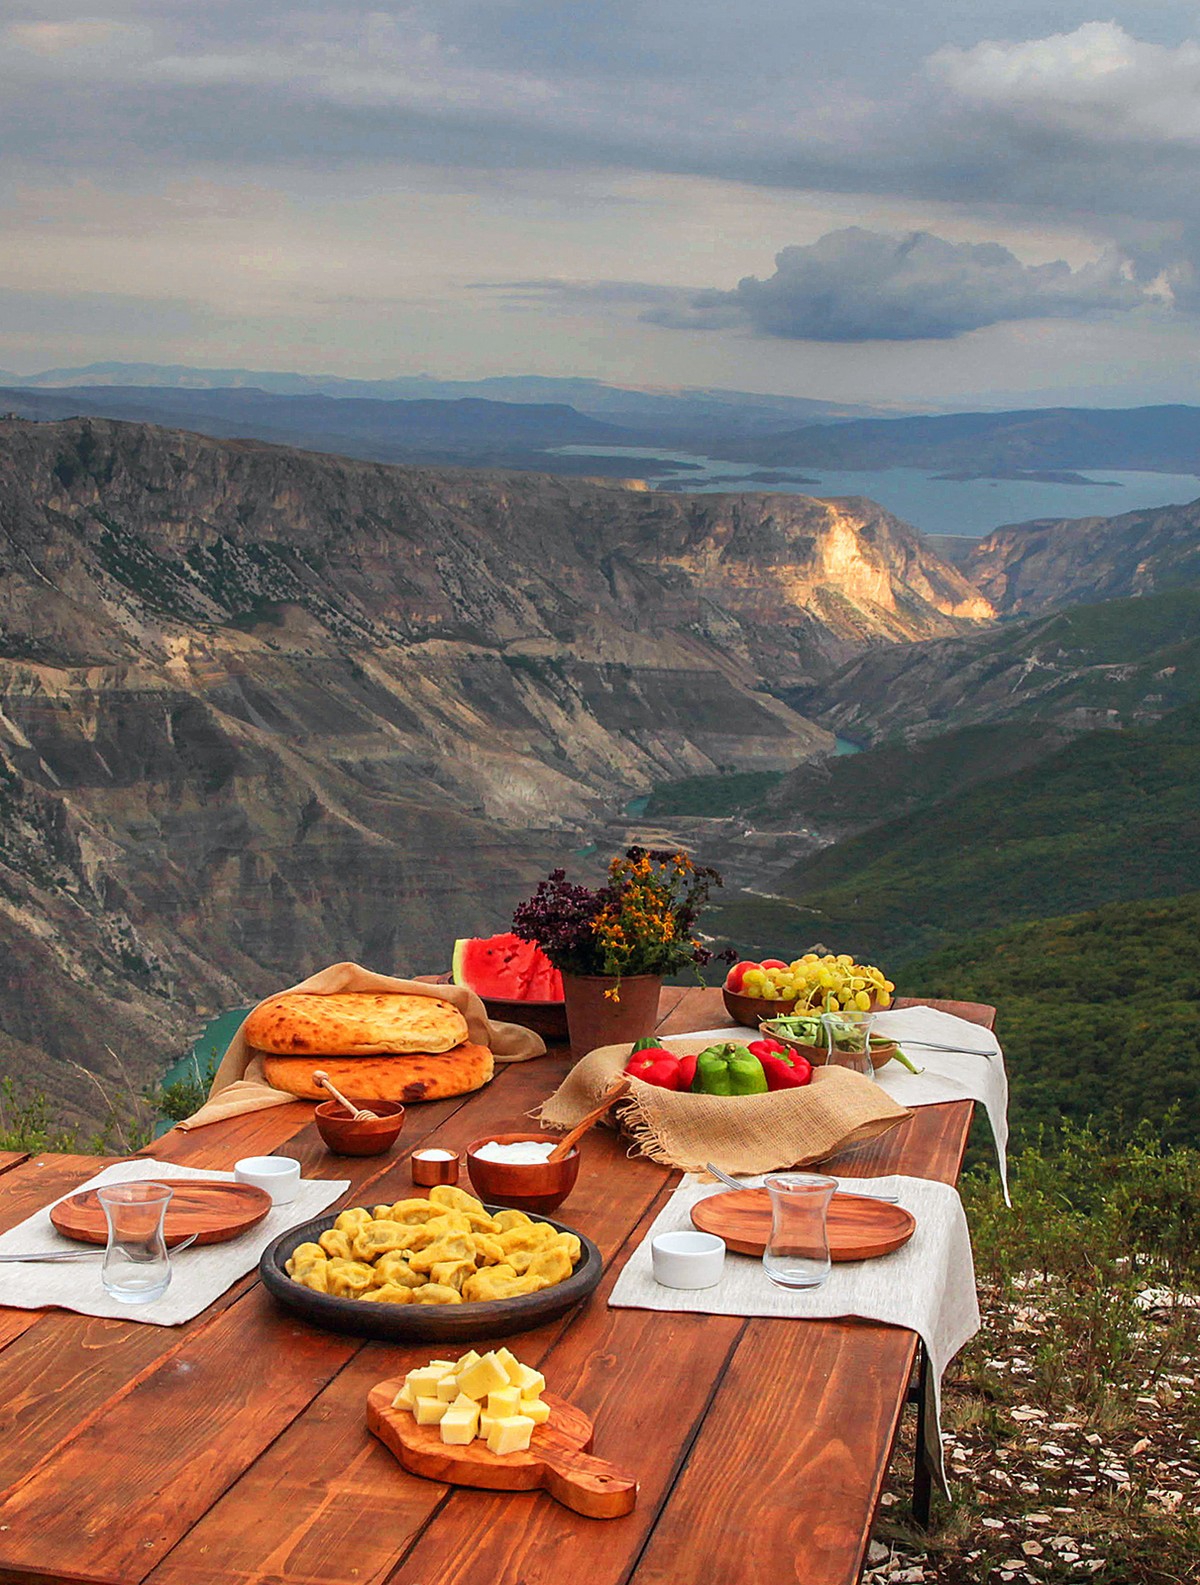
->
(176, 964), (545, 1129)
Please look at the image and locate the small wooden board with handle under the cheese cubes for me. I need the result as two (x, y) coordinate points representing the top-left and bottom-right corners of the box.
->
(366, 1377), (637, 1518)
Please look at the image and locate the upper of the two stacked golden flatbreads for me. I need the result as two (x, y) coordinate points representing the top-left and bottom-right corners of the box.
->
(243, 991), (468, 1052)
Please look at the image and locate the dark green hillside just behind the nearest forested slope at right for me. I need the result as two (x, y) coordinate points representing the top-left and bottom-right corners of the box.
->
(718, 705), (1200, 967)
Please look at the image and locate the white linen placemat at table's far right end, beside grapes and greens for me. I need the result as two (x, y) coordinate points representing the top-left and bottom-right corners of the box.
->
(678, 1006), (1011, 1205)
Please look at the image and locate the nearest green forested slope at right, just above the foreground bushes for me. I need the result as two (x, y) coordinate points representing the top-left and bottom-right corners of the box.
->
(904, 892), (1200, 1144)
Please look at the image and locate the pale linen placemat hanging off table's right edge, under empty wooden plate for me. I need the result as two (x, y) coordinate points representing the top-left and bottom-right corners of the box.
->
(609, 1178), (980, 1490)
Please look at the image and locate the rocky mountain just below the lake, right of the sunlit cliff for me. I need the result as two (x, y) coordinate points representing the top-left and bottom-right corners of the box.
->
(954, 499), (1200, 613)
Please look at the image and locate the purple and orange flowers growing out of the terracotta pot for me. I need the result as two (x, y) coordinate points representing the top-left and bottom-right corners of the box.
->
(512, 848), (721, 1002)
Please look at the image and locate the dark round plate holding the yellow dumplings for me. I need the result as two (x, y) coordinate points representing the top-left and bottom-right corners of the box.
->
(258, 1205), (604, 1337)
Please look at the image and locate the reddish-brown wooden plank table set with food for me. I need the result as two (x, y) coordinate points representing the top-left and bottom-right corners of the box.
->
(0, 989), (992, 1585)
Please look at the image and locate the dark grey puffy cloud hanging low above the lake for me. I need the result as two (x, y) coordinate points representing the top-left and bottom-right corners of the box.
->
(645, 227), (1148, 341)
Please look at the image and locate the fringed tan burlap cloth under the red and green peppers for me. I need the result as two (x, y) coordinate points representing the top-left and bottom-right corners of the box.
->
(536, 1035), (911, 1174)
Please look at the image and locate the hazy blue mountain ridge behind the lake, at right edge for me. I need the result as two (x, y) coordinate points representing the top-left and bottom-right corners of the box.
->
(735, 406), (1200, 477)
